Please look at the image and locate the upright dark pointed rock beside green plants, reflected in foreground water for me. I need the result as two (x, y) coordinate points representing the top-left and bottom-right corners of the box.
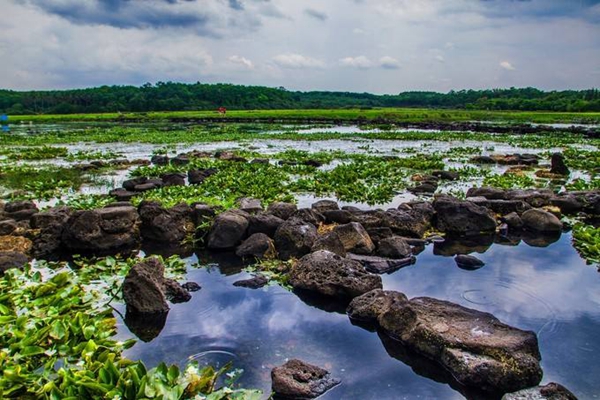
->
(123, 258), (169, 314)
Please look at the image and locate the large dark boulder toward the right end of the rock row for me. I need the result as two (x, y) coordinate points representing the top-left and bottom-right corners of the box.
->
(433, 196), (496, 235)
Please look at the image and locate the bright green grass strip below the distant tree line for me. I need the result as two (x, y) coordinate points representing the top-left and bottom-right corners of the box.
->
(9, 108), (600, 124)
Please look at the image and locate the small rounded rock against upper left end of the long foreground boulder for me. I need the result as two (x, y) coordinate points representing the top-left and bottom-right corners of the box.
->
(346, 289), (408, 322)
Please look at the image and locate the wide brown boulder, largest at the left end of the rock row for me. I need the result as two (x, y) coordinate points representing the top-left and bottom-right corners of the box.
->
(62, 207), (140, 255)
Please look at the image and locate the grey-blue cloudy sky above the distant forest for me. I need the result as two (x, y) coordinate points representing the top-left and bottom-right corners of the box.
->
(0, 0), (600, 93)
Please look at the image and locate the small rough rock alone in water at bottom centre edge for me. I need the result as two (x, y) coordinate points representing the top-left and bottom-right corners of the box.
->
(271, 359), (340, 399)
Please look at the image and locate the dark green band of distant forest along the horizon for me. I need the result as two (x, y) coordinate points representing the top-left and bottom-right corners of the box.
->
(0, 82), (600, 114)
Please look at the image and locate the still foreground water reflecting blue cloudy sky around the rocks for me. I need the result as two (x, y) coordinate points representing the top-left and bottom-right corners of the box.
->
(119, 234), (600, 399)
